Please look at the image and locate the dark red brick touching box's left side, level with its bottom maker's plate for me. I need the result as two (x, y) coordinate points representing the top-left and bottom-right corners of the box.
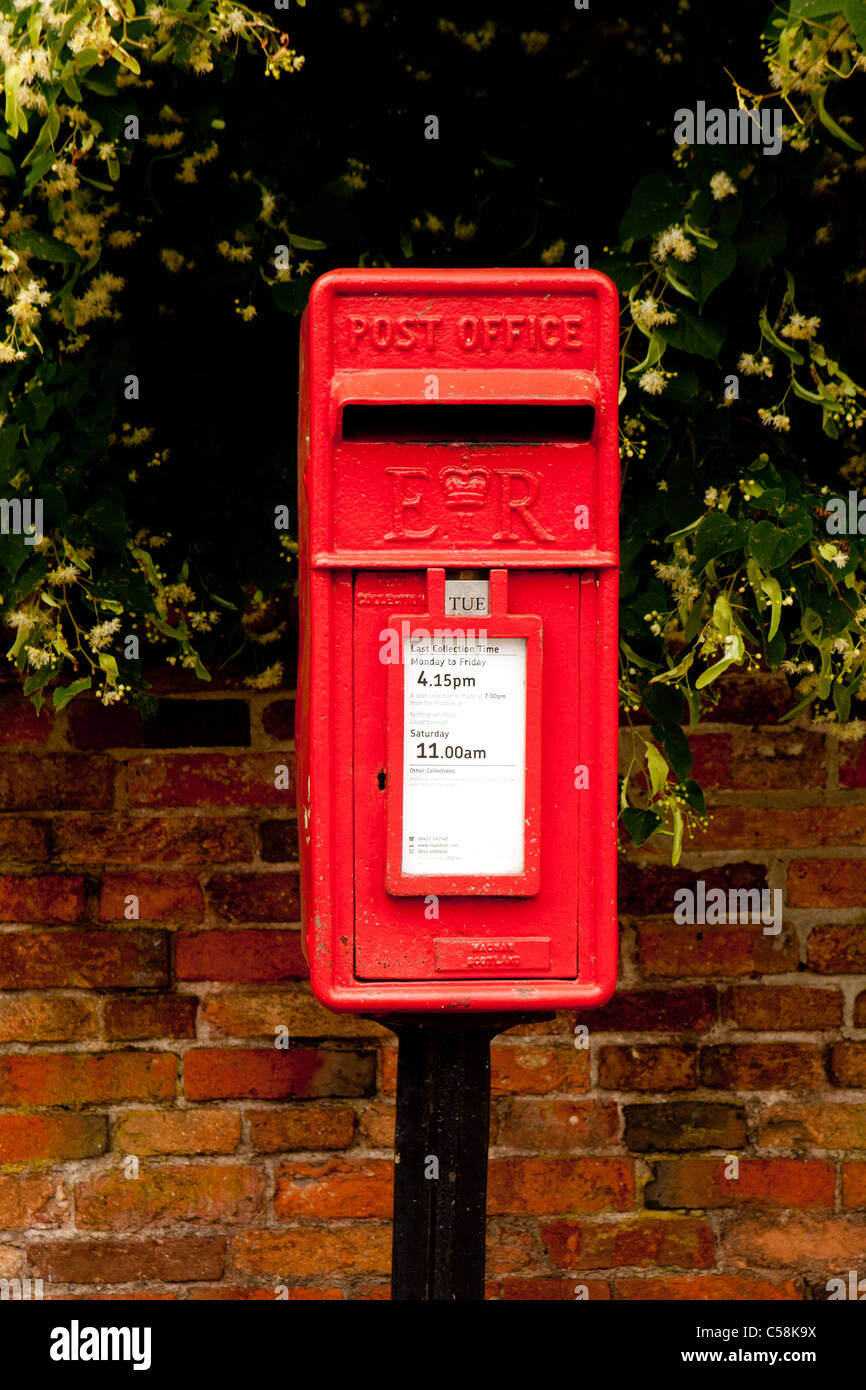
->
(175, 929), (310, 984)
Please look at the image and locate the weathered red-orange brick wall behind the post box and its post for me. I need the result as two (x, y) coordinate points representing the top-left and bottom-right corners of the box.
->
(0, 667), (866, 1300)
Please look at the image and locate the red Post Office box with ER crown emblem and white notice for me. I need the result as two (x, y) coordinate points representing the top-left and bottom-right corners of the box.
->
(296, 270), (619, 1013)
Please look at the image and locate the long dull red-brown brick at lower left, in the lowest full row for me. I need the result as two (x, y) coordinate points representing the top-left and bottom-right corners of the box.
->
(29, 1236), (225, 1278)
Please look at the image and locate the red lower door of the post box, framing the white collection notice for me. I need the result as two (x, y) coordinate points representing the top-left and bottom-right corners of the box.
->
(353, 569), (583, 981)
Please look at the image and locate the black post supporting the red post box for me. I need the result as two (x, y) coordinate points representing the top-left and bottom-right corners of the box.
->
(379, 1013), (553, 1301)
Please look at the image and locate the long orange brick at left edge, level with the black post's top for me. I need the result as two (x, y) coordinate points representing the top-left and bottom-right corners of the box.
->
(0, 1052), (177, 1106)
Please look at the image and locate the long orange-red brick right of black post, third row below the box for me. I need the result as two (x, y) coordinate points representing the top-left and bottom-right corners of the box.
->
(487, 1158), (634, 1216)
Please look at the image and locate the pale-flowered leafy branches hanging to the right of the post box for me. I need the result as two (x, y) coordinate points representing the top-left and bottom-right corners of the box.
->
(612, 0), (866, 862)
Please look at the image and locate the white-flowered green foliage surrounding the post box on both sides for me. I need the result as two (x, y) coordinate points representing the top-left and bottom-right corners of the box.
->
(0, 0), (866, 860)
